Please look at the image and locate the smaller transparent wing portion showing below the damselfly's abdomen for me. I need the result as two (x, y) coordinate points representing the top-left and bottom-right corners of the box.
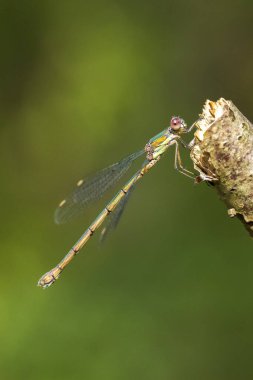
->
(100, 186), (135, 243)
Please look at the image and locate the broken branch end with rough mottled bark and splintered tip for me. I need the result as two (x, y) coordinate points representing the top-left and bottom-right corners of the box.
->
(190, 98), (253, 236)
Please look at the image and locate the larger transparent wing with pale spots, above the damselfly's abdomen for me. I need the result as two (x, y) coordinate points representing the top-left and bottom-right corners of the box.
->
(55, 150), (144, 224)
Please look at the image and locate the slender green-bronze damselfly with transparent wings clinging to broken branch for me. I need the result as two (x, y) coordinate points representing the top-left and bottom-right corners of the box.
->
(38, 116), (193, 288)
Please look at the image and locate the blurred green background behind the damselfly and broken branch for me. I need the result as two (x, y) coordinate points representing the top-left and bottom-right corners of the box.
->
(0, 0), (253, 380)
